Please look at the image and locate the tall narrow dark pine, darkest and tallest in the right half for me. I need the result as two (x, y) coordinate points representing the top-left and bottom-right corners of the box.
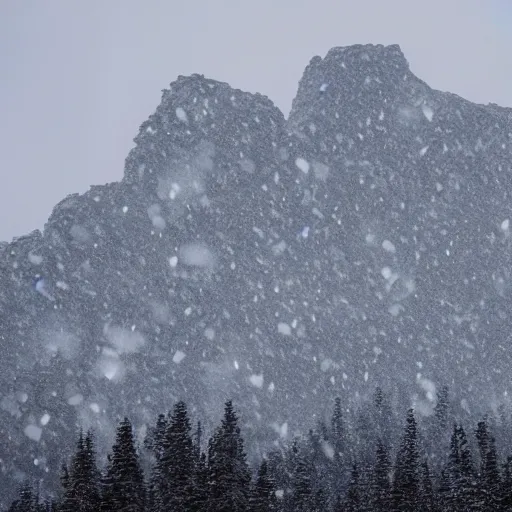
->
(393, 409), (419, 511)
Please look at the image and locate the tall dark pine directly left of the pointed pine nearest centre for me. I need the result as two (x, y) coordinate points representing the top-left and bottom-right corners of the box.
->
(153, 402), (196, 511)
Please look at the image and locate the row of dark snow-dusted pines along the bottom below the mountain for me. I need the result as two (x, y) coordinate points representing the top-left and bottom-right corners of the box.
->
(9, 388), (512, 512)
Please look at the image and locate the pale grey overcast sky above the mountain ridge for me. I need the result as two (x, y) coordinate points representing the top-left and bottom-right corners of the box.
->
(0, 0), (512, 240)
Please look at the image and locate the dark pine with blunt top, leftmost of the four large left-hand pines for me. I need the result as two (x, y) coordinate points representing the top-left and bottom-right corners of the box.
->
(60, 432), (100, 512)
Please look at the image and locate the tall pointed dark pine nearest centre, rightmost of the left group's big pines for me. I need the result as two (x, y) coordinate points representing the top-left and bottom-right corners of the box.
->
(208, 401), (251, 512)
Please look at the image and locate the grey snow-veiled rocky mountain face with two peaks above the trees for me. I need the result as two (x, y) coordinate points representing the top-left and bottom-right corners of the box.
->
(0, 45), (512, 500)
